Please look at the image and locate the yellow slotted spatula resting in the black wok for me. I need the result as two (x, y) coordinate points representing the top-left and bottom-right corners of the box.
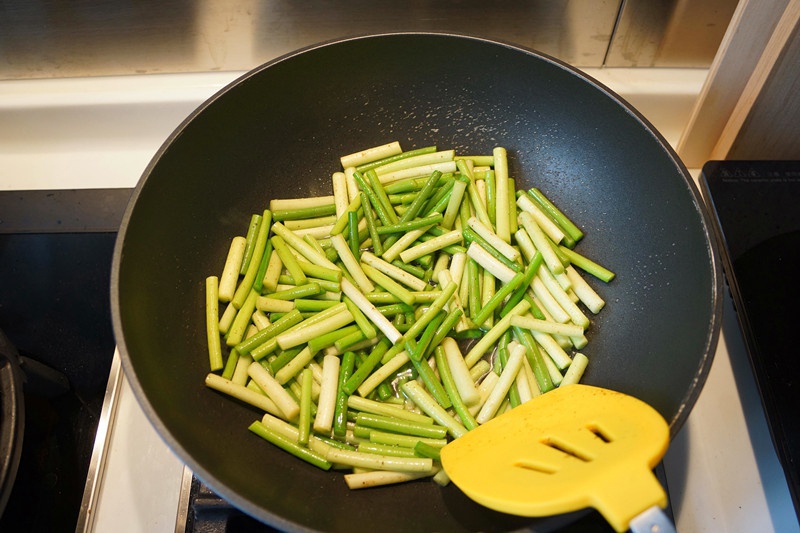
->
(441, 384), (674, 532)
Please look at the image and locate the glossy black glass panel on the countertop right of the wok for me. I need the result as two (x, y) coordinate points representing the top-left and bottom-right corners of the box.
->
(700, 161), (800, 514)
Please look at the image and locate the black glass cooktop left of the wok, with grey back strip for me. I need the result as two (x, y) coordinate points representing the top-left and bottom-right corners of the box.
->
(0, 189), (131, 532)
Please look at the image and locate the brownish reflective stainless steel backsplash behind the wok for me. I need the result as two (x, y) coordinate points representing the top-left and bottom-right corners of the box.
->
(0, 0), (737, 79)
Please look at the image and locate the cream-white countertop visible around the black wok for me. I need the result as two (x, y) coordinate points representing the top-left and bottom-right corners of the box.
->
(0, 69), (800, 533)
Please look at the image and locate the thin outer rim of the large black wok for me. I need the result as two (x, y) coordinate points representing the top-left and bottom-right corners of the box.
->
(110, 31), (723, 531)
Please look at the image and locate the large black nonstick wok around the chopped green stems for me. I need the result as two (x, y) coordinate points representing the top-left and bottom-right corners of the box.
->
(111, 34), (721, 531)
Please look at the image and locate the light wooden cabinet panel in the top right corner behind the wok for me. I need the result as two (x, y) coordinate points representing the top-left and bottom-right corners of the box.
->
(678, 0), (800, 162)
